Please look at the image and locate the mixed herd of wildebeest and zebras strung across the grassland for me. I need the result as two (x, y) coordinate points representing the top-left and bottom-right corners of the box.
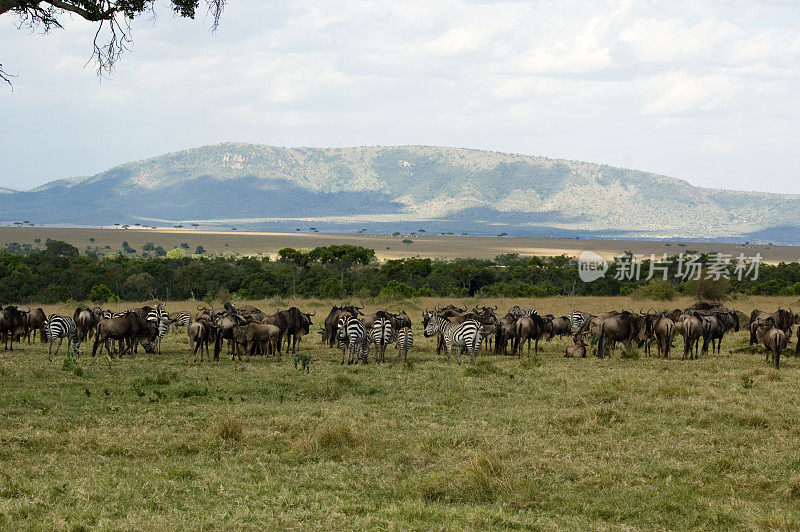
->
(0, 301), (800, 368)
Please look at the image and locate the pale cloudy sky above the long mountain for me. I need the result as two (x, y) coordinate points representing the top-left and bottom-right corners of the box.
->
(0, 0), (800, 193)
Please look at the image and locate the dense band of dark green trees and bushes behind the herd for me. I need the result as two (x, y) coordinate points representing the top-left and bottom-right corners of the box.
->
(0, 241), (800, 304)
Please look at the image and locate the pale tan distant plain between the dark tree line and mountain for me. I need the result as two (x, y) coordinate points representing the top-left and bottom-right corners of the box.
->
(0, 227), (800, 263)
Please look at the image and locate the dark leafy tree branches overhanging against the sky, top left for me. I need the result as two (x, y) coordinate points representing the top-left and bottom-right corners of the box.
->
(0, 0), (225, 84)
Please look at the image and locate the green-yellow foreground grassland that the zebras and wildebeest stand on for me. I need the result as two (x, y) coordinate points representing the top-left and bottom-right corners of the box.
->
(0, 297), (800, 530)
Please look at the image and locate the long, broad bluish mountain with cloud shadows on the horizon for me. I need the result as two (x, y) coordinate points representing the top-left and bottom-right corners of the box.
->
(0, 143), (800, 243)
